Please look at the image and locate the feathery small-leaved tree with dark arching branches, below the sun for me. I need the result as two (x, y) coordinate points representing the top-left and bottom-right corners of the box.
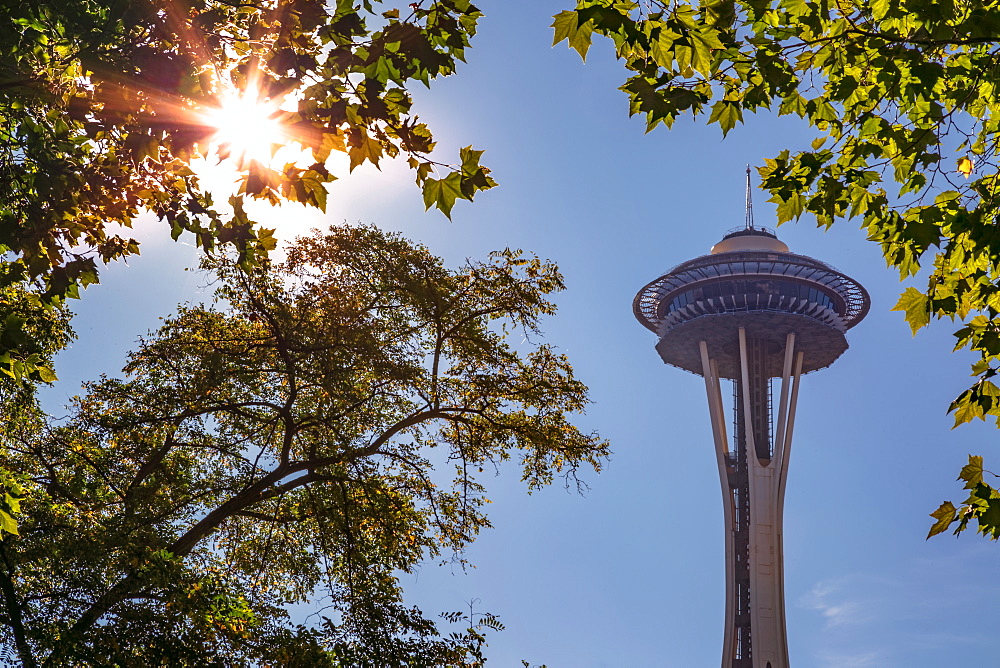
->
(0, 227), (607, 666)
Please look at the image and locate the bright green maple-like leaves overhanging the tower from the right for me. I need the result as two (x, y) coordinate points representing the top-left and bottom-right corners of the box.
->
(553, 0), (1000, 538)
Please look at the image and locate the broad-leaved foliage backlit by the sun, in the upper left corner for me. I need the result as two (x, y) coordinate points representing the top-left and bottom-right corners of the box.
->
(0, 0), (495, 374)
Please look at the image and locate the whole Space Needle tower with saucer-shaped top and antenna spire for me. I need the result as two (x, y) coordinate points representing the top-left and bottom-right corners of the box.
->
(633, 175), (870, 668)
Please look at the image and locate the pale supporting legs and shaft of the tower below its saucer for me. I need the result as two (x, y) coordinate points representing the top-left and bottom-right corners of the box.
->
(699, 327), (803, 668)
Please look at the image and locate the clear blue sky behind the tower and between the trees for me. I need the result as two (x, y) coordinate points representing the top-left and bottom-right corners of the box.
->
(39, 0), (1000, 668)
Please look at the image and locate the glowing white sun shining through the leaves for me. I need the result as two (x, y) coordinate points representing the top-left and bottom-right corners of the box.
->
(205, 89), (290, 164)
